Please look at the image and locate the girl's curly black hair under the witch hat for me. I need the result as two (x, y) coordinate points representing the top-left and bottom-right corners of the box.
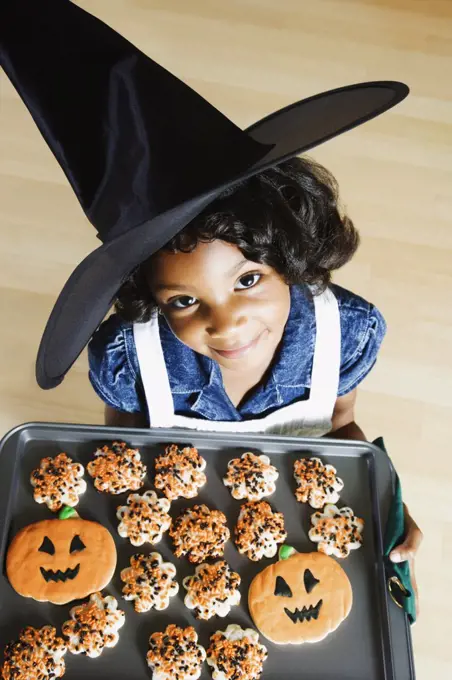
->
(115, 157), (359, 322)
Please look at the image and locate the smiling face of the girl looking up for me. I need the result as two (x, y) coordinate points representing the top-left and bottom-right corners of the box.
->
(147, 240), (290, 372)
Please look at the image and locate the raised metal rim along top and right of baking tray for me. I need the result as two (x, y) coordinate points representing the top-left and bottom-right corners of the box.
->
(0, 421), (415, 680)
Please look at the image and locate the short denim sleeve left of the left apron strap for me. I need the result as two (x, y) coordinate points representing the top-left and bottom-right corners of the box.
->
(88, 314), (142, 413)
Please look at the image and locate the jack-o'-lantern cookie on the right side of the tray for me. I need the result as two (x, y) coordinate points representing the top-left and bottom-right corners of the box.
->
(248, 546), (352, 644)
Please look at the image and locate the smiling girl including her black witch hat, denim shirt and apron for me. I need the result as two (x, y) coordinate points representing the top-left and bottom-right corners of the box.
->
(0, 0), (420, 616)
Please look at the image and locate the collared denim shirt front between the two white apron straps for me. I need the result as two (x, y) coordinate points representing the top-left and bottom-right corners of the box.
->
(159, 286), (316, 420)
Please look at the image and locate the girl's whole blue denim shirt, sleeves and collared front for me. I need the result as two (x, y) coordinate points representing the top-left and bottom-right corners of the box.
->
(88, 285), (386, 421)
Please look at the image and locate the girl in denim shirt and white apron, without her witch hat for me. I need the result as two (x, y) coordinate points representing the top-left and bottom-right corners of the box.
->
(89, 158), (422, 604)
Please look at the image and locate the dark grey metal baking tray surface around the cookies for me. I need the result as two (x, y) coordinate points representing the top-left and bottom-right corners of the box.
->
(0, 423), (415, 680)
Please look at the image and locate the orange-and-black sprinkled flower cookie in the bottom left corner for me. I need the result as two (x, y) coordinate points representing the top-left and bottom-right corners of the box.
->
(2, 626), (67, 680)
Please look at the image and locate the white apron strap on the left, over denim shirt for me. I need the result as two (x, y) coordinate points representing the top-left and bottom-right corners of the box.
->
(133, 314), (174, 427)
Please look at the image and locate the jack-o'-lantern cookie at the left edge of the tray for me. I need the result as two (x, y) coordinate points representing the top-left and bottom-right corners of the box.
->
(6, 508), (116, 604)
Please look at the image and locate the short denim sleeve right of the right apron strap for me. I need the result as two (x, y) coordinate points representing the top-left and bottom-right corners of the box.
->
(331, 285), (386, 396)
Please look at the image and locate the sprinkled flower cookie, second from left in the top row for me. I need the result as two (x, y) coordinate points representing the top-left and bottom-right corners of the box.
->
(86, 442), (146, 494)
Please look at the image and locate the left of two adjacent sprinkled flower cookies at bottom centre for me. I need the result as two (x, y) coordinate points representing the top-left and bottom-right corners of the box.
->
(147, 624), (206, 680)
